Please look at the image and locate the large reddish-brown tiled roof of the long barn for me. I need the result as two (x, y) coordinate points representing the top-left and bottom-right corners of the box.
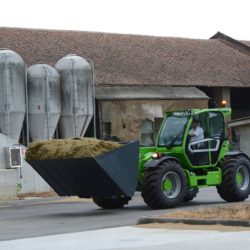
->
(0, 28), (250, 87)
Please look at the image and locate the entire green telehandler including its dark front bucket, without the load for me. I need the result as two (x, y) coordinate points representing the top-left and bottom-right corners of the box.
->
(28, 108), (250, 209)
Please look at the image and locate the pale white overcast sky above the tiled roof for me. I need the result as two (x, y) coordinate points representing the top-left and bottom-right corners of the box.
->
(0, 0), (250, 41)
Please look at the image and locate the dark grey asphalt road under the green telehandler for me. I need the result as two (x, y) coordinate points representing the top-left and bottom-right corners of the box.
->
(0, 188), (247, 240)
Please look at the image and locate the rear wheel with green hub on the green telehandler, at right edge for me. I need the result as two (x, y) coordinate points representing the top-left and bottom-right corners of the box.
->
(217, 155), (250, 202)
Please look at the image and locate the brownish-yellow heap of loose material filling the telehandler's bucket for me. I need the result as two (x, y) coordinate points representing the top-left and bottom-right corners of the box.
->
(26, 138), (121, 160)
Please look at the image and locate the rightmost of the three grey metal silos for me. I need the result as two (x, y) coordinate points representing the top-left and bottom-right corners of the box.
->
(55, 55), (94, 138)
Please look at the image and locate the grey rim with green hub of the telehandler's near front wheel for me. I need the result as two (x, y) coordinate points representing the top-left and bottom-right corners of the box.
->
(161, 171), (181, 199)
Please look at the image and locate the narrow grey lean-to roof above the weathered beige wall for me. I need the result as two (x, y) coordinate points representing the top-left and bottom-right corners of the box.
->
(96, 86), (208, 100)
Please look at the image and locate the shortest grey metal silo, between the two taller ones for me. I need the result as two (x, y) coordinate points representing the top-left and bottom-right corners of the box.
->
(27, 64), (61, 141)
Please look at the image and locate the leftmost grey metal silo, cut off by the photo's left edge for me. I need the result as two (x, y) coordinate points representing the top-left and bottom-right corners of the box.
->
(0, 49), (26, 141)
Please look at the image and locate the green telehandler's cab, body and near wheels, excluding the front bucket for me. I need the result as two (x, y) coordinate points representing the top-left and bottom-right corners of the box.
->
(139, 108), (250, 209)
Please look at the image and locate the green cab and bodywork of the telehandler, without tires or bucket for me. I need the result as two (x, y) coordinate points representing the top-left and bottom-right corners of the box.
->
(138, 108), (231, 190)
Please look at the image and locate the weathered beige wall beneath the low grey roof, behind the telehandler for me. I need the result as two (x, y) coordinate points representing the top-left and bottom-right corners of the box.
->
(99, 99), (207, 141)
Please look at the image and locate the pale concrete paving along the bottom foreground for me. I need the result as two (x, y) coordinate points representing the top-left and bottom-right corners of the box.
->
(0, 227), (250, 250)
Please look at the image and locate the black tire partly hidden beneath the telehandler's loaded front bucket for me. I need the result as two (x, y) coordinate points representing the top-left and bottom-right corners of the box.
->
(93, 196), (131, 209)
